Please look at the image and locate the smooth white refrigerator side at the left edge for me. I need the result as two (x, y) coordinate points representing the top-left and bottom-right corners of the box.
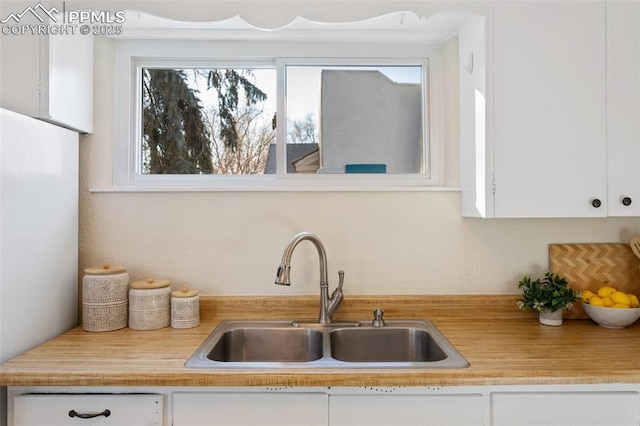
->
(0, 109), (80, 424)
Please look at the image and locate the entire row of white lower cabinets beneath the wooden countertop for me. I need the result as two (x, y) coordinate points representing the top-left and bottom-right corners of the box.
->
(8, 383), (640, 426)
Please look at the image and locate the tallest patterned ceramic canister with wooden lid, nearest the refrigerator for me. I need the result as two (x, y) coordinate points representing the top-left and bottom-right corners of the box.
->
(82, 265), (129, 331)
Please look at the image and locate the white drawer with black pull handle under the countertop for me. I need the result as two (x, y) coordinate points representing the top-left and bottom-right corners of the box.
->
(13, 394), (163, 426)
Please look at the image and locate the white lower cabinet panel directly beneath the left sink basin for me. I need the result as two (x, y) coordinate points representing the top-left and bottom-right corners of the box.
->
(172, 392), (328, 426)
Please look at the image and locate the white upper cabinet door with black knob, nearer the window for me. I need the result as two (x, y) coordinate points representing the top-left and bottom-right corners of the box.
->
(492, 1), (607, 217)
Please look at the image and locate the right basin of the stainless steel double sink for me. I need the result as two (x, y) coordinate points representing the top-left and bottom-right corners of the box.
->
(330, 326), (447, 362)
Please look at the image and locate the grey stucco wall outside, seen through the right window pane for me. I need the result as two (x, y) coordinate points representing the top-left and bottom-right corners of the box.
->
(320, 70), (422, 173)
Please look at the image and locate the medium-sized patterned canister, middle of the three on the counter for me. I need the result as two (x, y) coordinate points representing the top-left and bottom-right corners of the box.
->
(129, 278), (171, 330)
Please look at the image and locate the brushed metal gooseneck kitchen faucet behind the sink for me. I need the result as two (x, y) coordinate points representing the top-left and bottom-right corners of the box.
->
(275, 232), (344, 324)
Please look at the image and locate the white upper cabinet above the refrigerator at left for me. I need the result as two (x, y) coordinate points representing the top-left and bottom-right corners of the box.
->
(0, 18), (93, 133)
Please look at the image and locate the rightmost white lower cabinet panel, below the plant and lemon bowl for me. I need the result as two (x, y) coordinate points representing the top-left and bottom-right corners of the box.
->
(491, 392), (640, 426)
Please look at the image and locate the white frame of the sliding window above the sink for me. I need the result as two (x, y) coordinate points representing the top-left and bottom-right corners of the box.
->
(113, 40), (444, 191)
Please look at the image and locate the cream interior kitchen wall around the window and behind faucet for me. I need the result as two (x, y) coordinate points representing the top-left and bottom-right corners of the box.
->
(80, 35), (640, 297)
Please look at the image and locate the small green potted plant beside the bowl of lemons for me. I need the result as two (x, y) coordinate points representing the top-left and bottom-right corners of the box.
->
(517, 272), (579, 326)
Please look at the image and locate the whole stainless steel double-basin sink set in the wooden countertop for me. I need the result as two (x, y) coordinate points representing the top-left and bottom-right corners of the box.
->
(185, 320), (469, 369)
